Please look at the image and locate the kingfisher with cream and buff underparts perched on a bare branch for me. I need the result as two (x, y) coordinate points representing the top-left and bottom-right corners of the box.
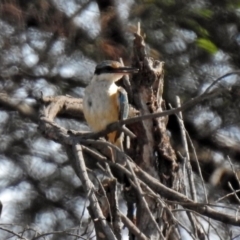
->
(83, 61), (138, 150)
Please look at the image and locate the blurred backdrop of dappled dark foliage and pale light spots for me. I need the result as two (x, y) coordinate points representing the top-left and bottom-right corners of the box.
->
(0, 0), (240, 239)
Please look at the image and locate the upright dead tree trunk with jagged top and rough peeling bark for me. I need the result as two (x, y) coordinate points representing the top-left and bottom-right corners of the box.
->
(124, 34), (178, 239)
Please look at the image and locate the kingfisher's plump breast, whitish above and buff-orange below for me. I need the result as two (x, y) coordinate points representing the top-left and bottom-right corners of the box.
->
(83, 82), (119, 132)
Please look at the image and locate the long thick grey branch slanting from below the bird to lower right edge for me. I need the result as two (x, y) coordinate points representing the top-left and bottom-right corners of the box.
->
(40, 109), (240, 226)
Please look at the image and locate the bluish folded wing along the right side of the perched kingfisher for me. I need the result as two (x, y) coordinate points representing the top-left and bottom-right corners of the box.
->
(118, 87), (129, 120)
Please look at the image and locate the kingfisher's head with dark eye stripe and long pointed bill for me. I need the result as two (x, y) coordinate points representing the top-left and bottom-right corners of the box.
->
(94, 60), (138, 82)
